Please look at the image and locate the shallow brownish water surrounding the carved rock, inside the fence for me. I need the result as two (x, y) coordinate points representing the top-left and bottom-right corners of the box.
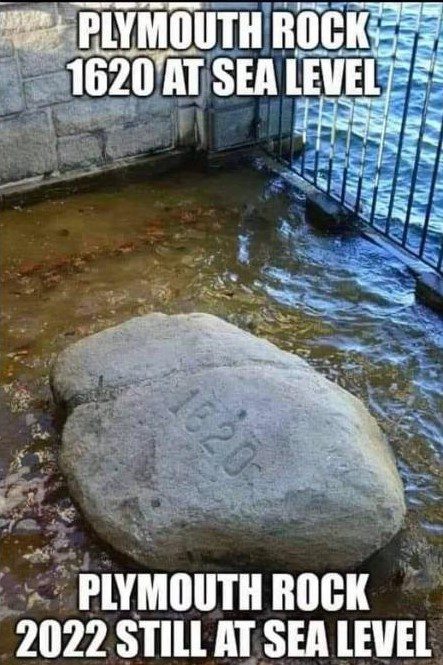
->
(0, 166), (443, 662)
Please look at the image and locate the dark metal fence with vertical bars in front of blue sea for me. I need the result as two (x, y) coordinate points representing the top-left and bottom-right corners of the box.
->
(268, 2), (443, 274)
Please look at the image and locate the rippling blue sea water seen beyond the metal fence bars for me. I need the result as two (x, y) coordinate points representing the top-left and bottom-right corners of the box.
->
(296, 2), (443, 264)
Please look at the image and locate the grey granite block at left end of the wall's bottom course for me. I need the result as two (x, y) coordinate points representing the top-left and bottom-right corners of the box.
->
(0, 111), (57, 182)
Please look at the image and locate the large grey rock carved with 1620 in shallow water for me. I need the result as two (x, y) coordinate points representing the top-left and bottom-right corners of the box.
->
(52, 314), (405, 570)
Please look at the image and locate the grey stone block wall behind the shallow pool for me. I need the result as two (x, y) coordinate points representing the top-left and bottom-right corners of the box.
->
(0, 2), (292, 195)
